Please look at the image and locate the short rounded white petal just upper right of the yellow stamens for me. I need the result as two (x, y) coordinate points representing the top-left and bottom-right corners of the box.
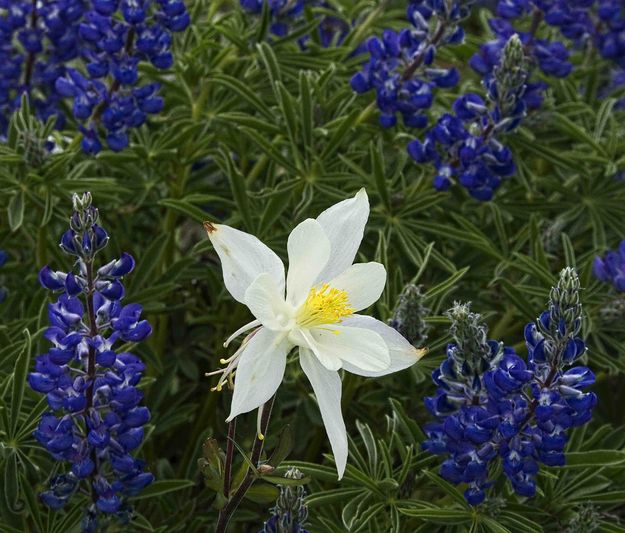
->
(329, 261), (386, 311)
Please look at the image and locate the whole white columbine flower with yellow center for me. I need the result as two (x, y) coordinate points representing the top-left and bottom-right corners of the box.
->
(205, 189), (425, 478)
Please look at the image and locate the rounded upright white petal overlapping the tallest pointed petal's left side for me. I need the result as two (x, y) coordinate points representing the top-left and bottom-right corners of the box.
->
(286, 218), (330, 306)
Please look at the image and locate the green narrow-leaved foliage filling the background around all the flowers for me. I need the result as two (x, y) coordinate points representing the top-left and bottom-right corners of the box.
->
(0, 0), (625, 533)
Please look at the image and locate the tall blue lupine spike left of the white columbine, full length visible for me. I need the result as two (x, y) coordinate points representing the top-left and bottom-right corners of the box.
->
(28, 193), (154, 532)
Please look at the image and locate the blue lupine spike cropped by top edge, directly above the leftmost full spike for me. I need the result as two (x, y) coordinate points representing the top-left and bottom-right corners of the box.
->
(55, 0), (190, 154)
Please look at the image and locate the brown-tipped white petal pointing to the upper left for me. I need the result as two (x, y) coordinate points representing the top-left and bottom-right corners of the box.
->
(205, 224), (284, 303)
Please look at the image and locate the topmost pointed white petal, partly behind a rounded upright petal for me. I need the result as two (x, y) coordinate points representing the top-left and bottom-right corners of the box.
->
(317, 189), (369, 283)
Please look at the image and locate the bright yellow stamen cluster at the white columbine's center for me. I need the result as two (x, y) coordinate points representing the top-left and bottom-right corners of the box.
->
(297, 283), (354, 328)
